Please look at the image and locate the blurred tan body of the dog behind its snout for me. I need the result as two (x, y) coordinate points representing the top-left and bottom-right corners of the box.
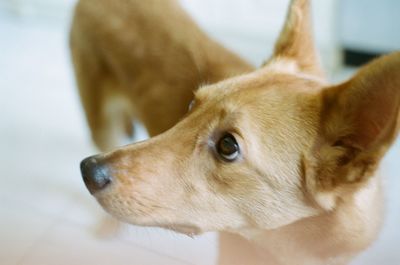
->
(70, 0), (252, 150)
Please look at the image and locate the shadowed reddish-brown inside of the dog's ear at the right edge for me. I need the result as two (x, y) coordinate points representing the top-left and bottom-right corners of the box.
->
(321, 53), (400, 152)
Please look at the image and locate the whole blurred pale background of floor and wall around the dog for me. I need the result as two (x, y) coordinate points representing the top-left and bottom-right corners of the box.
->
(0, 0), (400, 265)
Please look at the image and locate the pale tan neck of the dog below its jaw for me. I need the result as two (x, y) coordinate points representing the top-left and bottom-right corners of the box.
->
(233, 173), (383, 265)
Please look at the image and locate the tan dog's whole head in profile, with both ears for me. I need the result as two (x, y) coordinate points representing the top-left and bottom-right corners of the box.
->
(81, 0), (400, 233)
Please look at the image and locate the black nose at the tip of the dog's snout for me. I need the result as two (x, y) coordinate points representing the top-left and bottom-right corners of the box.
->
(81, 156), (112, 194)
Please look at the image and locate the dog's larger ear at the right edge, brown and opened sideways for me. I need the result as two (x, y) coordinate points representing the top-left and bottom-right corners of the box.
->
(308, 53), (400, 208)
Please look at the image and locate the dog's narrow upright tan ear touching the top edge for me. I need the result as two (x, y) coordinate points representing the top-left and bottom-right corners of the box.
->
(266, 0), (324, 77)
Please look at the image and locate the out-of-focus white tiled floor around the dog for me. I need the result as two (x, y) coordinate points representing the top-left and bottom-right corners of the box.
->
(0, 10), (400, 265)
